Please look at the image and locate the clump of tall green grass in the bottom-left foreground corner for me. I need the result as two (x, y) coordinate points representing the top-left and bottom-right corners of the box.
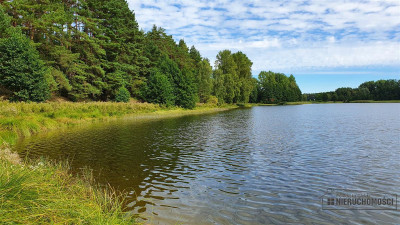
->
(0, 150), (135, 224)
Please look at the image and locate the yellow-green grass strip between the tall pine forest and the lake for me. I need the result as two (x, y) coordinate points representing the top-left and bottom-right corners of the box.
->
(0, 101), (237, 145)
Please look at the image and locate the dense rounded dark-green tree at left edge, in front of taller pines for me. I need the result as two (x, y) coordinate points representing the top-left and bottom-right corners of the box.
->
(0, 31), (50, 102)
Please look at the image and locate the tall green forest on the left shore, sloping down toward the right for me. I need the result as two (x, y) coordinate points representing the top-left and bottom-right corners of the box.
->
(0, 0), (301, 108)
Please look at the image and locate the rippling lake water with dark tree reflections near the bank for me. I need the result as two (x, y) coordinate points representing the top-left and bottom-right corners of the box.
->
(16, 103), (400, 224)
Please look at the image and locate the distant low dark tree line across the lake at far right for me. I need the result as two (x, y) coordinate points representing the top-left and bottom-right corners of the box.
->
(303, 79), (400, 102)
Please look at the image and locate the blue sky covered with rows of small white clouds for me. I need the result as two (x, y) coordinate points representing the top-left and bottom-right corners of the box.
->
(128, 0), (400, 93)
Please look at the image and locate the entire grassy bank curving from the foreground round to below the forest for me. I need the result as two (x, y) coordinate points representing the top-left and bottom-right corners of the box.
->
(0, 101), (237, 224)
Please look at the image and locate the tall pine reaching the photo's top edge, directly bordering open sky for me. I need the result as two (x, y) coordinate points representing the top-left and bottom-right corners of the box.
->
(88, 0), (149, 99)
